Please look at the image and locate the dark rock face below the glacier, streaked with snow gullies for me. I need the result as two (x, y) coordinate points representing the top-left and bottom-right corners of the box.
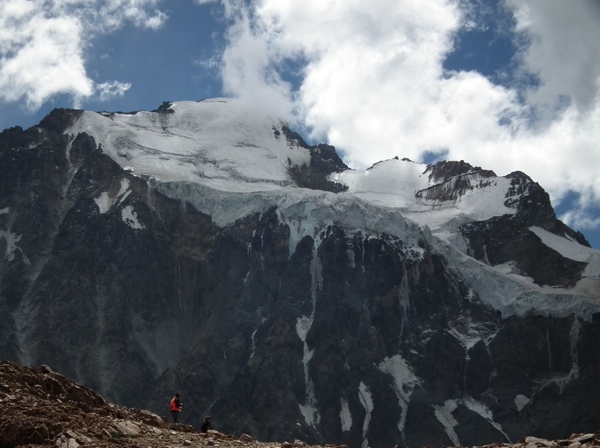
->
(0, 105), (600, 448)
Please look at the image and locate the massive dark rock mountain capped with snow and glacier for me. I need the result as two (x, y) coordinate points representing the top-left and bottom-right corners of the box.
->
(0, 99), (600, 448)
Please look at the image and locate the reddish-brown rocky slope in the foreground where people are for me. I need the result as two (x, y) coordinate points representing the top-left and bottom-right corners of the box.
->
(0, 362), (600, 448)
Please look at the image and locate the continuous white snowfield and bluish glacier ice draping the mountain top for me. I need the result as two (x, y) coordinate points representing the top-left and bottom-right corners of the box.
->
(67, 99), (600, 316)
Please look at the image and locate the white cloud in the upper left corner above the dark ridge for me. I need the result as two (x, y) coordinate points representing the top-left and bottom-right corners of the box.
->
(0, 0), (166, 110)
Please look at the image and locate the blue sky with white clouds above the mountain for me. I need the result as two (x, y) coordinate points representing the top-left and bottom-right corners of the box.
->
(0, 0), (600, 248)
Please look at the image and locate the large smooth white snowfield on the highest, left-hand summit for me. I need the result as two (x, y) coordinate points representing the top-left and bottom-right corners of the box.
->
(66, 100), (310, 191)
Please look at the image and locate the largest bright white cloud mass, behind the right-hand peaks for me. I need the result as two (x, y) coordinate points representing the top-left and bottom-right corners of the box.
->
(222, 0), (600, 236)
